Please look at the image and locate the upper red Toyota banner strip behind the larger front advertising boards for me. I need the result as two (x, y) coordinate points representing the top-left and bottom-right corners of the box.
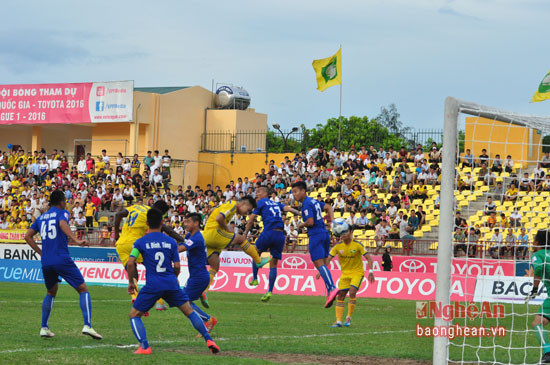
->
(280, 253), (515, 276)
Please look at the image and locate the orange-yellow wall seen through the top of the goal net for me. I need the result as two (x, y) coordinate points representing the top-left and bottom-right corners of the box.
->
(465, 117), (542, 166)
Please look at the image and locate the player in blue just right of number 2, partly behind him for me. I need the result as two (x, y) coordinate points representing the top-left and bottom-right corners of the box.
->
(178, 213), (218, 337)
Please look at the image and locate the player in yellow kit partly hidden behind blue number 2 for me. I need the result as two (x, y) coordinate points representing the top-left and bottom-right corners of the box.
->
(115, 200), (185, 310)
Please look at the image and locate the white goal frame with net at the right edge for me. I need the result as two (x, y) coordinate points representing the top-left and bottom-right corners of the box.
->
(433, 97), (550, 365)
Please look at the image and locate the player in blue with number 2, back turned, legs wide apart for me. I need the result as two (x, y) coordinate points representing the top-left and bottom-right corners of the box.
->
(128, 208), (220, 355)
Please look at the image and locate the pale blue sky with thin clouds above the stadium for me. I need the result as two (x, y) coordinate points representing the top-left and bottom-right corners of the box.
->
(0, 0), (550, 128)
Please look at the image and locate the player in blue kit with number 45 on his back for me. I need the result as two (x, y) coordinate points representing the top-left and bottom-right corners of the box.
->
(25, 190), (103, 340)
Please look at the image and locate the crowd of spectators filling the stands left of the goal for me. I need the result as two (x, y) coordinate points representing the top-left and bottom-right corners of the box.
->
(0, 143), (441, 250)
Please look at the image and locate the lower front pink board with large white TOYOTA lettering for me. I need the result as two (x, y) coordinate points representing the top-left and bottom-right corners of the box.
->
(210, 267), (476, 301)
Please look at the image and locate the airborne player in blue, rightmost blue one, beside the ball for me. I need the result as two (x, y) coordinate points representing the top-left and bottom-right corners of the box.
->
(292, 181), (338, 308)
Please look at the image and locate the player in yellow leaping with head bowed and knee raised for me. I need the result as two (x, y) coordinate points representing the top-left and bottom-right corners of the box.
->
(201, 195), (269, 308)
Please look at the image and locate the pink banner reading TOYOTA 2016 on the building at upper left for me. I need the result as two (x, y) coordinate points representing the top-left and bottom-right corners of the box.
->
(0, 81), (134, 124)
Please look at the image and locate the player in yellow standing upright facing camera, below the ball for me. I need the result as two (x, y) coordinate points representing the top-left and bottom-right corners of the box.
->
(327, 227), (374, 328)
